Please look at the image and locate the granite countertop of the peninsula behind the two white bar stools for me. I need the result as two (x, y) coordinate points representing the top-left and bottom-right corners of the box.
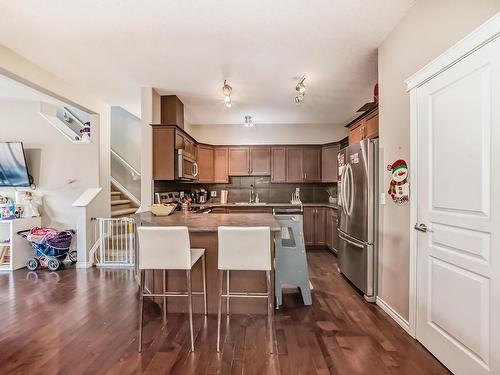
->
(133, 211), (281, 233)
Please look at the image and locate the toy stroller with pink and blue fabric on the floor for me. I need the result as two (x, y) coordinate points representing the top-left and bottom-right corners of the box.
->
(17, 227), (77, 271)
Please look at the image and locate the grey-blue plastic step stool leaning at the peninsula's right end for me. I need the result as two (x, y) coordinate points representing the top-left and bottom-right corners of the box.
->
(274, 215), (312, 308)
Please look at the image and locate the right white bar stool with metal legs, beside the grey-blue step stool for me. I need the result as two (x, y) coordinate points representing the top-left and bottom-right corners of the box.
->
(217, 227), (274, 353)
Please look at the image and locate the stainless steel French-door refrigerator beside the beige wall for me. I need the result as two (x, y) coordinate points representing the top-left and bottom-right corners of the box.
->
(337, 140), (378, 302)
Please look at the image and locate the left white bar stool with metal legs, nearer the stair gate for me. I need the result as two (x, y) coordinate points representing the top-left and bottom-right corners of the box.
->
(137, 226), (207, 353)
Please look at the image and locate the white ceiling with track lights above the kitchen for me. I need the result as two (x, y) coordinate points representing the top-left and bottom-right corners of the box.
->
(0, 0), (414, 124)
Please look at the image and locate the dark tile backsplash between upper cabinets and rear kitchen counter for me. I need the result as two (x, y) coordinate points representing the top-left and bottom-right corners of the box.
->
(154, 176), (335, 203)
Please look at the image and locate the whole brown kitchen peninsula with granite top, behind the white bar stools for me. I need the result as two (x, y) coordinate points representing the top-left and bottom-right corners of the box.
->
(134, 212), (281, 314)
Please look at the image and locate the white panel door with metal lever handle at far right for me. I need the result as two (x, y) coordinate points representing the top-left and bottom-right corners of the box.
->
(416, 38), (500, 375)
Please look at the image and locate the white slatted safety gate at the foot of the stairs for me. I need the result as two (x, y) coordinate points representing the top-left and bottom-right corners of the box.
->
(96, 217), (136, 267)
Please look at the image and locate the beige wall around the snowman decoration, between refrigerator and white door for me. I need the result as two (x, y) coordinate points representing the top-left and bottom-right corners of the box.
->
(378, 0), (500, 320)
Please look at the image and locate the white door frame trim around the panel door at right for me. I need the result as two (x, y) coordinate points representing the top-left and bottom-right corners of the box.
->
(405, 12), (500, 338)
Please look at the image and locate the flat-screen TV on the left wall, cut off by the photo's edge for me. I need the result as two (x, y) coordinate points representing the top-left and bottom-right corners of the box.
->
(0, 142), (30, 187)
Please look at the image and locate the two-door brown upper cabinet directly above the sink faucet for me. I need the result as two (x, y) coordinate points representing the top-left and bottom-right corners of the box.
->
(229, 147), (271, 176)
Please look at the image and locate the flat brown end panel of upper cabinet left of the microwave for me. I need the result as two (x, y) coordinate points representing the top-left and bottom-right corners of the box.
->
(153, 127), (175, 180)
